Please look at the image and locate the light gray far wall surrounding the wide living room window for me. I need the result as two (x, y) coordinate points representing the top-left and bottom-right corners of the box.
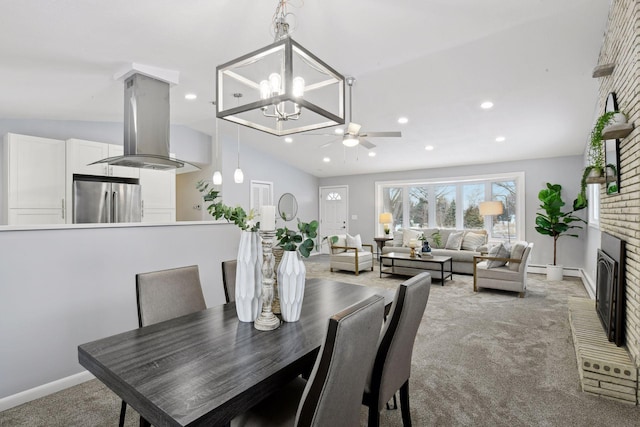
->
(319, 156), (586, 267)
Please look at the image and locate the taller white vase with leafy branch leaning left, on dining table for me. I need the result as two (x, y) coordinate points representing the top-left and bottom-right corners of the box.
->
(196, 181), (262, 322)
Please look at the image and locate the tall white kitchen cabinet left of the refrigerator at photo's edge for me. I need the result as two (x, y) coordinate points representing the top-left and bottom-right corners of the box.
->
(1, 133), (66, 224)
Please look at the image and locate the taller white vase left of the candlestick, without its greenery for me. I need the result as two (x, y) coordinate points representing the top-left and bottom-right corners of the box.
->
(236, 231), (262, 322)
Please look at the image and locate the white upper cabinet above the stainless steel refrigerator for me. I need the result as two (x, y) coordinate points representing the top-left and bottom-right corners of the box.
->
(67, 139), (140, 178)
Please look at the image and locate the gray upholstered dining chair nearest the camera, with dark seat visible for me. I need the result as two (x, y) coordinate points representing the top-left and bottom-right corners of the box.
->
(231, 295), (384, 427)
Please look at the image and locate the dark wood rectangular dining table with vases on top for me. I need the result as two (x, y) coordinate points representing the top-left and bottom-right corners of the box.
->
(78, 279), (394, 426)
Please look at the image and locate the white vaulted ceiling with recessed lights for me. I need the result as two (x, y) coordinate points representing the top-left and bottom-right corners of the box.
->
(0, 0), (609, 177)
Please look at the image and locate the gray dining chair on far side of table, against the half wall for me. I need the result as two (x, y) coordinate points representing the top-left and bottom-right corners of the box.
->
(119, 265), (207, 426)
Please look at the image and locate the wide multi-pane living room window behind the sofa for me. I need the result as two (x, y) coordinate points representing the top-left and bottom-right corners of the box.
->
(376, 172), (524, 240)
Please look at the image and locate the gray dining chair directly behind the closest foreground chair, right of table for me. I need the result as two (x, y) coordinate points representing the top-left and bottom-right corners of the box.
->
(362, 273), (431, 427)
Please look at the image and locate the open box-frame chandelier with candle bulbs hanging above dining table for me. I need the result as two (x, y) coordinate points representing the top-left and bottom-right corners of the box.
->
(216, 0), (345, 136)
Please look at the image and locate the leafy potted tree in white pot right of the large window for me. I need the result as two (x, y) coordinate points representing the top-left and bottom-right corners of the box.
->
(536, 183), (585, 280)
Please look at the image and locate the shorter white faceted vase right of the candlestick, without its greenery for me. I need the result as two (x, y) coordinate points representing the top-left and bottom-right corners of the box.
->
(278, 251), (307, 322)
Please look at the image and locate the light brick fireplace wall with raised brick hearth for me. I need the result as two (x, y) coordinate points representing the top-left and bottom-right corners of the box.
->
(569, 0), (640, 404)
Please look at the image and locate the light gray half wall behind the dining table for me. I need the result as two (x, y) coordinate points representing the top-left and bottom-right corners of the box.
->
(0, 224), (239, 399)
